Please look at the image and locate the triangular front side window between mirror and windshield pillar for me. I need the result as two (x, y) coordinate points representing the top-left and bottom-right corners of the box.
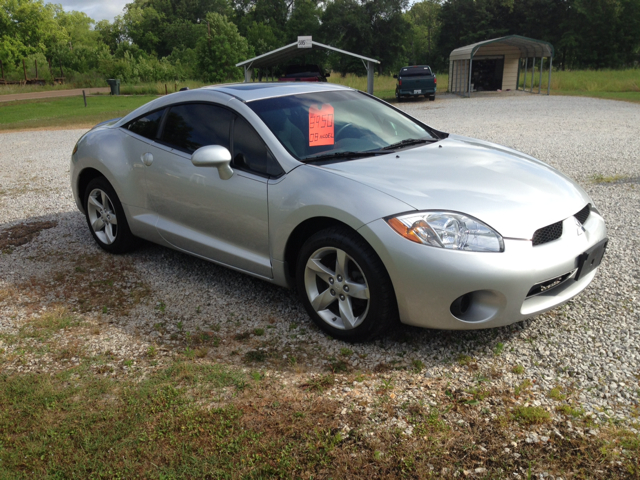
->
(232, 117), (284, 177)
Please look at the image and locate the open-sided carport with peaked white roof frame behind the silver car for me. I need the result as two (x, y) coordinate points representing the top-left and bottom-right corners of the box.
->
(236, 37), (380, 95)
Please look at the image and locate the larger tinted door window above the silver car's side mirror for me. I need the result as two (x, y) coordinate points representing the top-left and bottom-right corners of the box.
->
(161, 103), (233, 153)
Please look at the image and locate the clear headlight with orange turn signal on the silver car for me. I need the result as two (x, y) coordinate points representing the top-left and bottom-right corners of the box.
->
(386, 212), (504, 252)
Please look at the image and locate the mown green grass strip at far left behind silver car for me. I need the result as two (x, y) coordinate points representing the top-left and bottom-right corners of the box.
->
(0, 96), (157, 131)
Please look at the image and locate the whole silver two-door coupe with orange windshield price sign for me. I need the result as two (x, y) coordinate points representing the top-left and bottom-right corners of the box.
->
(71, 83), (607, 341)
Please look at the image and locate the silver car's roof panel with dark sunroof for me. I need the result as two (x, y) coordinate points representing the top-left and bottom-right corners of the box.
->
(200, 82), (353, 102)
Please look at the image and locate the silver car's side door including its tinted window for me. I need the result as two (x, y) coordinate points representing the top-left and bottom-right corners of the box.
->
(146, 103), (272, 278)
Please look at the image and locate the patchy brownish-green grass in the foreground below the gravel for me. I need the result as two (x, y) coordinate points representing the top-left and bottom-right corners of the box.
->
(0, 309), (640, 479)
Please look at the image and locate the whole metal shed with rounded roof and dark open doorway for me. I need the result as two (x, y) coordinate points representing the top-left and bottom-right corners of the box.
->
(449, 35), (553, 97)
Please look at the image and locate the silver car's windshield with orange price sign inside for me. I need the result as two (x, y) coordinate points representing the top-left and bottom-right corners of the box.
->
(248, 91), (435, 161)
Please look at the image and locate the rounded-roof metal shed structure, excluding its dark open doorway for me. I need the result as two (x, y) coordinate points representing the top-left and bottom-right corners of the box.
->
(449, 35), (554, 97)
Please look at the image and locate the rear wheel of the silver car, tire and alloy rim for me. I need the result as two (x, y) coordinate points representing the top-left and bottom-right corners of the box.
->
(83, 177), (138, 253)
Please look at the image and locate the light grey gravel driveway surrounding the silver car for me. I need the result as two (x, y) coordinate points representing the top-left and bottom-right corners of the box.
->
(0, 95), (640, 432)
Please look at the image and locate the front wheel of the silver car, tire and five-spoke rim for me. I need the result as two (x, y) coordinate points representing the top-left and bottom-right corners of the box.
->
(296, 227), (398, 342)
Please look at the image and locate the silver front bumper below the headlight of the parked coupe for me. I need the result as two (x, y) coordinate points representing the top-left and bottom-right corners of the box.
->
(359, 210), (607, 330)
